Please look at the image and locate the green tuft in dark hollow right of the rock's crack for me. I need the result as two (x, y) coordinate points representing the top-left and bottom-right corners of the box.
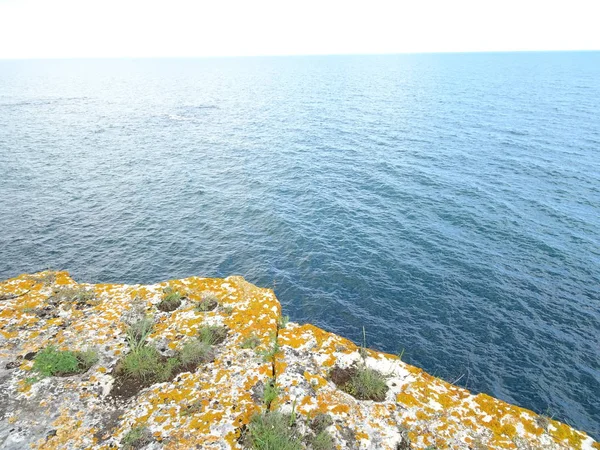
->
(331, 366), (388, 402)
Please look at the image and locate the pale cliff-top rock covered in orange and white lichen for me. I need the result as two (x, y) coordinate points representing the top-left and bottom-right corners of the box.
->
(0, 272), (600, 450)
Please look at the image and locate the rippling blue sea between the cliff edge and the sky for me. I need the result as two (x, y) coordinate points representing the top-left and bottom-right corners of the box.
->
(0, 52), (600, 438)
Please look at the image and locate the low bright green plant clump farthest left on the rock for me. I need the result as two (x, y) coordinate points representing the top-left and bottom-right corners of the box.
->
(33, 346), (98, 377)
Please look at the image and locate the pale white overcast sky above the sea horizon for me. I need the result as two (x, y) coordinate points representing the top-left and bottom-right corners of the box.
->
(0, 0), (600, 58)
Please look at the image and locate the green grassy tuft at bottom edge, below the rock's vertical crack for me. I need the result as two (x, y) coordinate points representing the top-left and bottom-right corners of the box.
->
(247, 412), (302, 450)
